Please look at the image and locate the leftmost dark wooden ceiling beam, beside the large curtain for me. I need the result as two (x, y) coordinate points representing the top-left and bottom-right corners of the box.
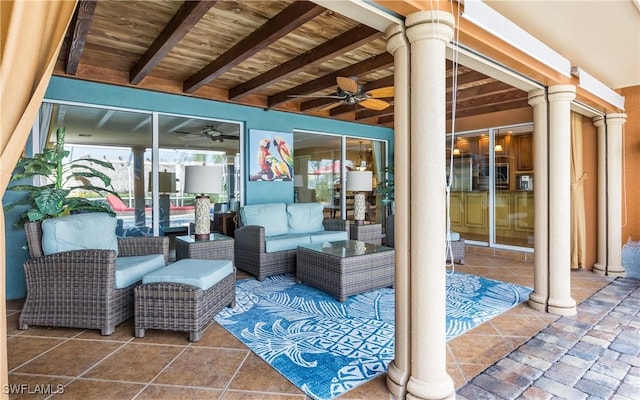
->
(64, 1), (98, 75)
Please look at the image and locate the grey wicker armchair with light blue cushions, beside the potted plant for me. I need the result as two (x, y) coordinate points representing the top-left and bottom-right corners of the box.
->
(19, 213), (169, 335)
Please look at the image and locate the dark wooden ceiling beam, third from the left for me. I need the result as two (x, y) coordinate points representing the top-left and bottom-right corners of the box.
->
(183, 1), (325, 93)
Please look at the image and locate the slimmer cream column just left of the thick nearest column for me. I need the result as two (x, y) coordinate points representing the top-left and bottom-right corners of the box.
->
(386, 25), (411, 399)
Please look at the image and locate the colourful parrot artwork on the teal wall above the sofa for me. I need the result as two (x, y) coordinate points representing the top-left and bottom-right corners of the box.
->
(249, 129), (293, 181)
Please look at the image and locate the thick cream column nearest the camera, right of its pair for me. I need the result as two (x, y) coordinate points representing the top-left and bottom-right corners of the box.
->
(404, 11), (455, 399)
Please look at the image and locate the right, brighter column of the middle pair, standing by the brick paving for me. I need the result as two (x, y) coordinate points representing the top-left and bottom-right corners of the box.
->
(547, 85), (576, 315)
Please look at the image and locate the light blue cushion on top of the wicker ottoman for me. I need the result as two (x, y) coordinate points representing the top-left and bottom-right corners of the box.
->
(142, 258), (233, 290)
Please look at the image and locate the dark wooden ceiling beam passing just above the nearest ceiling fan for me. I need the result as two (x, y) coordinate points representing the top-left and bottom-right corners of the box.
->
(267, 53), (393, 108)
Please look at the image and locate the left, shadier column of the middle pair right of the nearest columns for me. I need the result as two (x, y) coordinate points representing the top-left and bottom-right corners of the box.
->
(529, 89), (549, 311)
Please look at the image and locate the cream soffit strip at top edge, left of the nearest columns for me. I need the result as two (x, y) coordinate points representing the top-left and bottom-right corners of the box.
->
(311, 0), (403, 32)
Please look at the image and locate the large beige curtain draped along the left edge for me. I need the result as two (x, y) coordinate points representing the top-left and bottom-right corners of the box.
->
(0, 0), (76, 398)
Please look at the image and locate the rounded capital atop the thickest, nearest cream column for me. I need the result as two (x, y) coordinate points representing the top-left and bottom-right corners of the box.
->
(405, 11), (455, 43)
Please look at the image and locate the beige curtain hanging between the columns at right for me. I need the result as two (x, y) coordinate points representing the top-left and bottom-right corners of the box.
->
(571, 112), (587, 269)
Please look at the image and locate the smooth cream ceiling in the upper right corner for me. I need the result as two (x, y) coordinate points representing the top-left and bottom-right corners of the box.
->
(484, 0), (640, 89)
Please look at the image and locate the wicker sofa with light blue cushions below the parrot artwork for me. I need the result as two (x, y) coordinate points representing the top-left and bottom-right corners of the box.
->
(234, 203), (349, 280)
